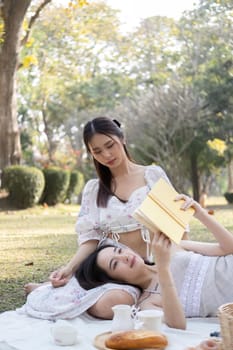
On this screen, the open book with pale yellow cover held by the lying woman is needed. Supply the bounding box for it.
[133,178,194,244]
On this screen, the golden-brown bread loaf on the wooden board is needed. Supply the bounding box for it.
[105,329,168,350]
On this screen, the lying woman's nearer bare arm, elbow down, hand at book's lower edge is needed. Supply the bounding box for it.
[142,232,186,329]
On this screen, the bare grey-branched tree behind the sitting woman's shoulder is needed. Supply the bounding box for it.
[116,79,197,191]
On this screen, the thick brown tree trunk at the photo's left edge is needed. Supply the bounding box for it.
[0,0,31,170]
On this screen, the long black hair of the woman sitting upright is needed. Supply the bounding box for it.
[83,117,132,208]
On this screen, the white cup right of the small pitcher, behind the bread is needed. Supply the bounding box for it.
[137,309,164,331]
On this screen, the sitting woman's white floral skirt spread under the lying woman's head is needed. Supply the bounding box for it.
[17,277,140,320]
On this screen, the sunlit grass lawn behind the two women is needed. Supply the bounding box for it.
[0,198,233,312]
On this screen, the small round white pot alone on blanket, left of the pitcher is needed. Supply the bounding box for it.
[51,320,78,345]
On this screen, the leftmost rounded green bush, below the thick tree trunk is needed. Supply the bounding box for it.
[2,165,45,209]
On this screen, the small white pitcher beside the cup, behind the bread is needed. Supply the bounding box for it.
[111,304,134,332]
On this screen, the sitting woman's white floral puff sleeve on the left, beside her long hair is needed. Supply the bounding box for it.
[75,179,101,245]
